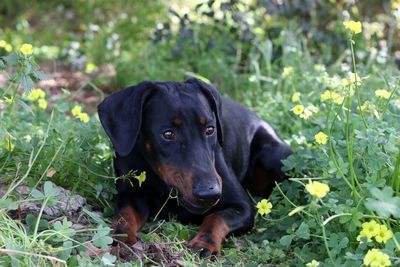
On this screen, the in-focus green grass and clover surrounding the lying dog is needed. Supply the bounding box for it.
[0,23,400,266]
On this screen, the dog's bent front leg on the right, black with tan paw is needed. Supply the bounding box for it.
[188,151,254,257]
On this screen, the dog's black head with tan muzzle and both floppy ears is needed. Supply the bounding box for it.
[98,78,223,214]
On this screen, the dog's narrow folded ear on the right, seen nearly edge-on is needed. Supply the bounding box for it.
[185,78,224,147]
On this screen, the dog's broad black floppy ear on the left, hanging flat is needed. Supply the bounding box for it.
[97,81,155,156]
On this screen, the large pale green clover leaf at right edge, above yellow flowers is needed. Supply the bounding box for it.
[365,186,400,218]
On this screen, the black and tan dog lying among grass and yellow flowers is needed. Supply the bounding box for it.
[98,78,291,256]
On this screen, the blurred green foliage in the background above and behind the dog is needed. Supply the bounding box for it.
[0,0,400,99]
